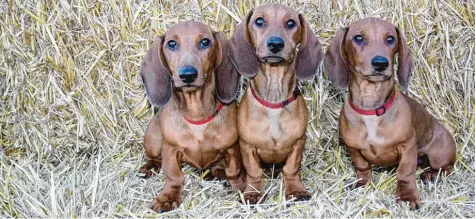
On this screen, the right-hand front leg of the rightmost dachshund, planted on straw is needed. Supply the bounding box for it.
[396,137,421,210]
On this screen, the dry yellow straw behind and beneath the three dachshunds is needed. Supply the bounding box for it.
[0,0,475,217]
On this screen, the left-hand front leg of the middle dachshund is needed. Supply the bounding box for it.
[240,139,263,204]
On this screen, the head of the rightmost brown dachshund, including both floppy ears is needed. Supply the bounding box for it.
[324,18,413,89]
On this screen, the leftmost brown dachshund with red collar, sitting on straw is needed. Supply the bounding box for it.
[140,22,246,211]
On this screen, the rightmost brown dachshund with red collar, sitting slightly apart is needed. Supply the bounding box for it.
[324,18,456,210]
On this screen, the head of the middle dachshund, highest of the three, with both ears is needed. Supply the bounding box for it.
[228,4,322,80]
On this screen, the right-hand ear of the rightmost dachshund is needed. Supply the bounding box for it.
[395,27,413,90]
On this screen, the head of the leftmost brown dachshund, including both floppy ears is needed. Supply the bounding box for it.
[141,21,239,106]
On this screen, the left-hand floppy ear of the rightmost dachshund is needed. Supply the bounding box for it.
[324,28,350,88]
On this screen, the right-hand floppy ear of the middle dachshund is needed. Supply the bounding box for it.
[295,14,322,80]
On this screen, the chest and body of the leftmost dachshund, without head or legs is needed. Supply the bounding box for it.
[152,92,239,169]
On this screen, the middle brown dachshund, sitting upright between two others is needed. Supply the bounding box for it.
[228,4,323,204]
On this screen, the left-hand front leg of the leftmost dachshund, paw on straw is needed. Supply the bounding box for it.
[152,144,184,212]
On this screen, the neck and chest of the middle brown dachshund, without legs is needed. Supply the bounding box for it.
[238,64,307,163]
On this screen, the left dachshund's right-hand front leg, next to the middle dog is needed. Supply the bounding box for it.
[225,142,246,192]
